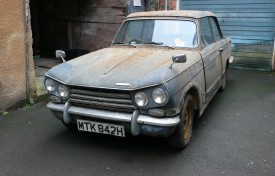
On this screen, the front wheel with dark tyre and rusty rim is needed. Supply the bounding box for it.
[168,94,194,149]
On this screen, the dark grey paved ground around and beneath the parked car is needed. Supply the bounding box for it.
[0,69,275,176]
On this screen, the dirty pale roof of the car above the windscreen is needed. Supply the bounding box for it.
[126,10,215,19]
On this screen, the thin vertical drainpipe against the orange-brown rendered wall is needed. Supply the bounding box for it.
[25,0,30,100]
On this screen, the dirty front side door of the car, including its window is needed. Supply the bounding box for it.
[200,17,222,102]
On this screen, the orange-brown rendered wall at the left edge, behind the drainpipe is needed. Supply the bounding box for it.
[0,0,35,112]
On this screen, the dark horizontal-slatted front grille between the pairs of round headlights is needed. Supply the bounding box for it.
[70,88,135,113]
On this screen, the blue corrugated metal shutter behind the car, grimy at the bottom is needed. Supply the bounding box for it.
[180,0,275,70]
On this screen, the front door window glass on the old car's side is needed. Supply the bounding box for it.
[200,17,215,46]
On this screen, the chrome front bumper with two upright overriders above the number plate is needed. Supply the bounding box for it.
[47,101,180,136]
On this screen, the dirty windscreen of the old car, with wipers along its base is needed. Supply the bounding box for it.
[113,20,198,48]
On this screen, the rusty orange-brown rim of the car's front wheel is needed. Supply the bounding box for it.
[183,105,192,140]
